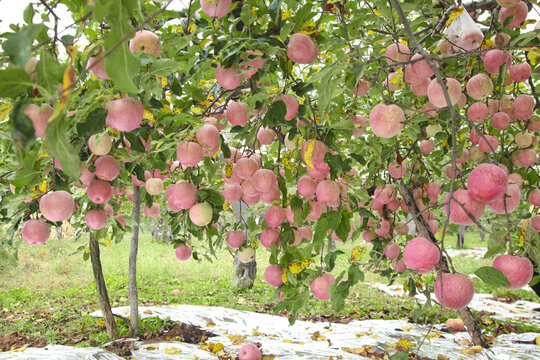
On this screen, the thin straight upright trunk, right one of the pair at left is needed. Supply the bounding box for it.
[128,185,141,336]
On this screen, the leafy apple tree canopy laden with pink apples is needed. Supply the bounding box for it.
[0,0,540,352]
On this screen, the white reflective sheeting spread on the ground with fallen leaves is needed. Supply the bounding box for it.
[0,305,540,360]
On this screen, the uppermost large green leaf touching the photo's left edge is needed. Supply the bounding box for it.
[2,24,47,68]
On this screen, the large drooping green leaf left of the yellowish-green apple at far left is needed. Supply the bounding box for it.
[45,114,81,179]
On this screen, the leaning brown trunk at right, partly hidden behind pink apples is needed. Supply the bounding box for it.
[400,181,489,348]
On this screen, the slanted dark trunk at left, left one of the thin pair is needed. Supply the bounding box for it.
[90,232,118,340]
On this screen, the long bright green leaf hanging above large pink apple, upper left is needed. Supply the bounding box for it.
[104,5,139,93]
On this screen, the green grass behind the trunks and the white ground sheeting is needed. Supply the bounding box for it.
[0,229,540,346]
